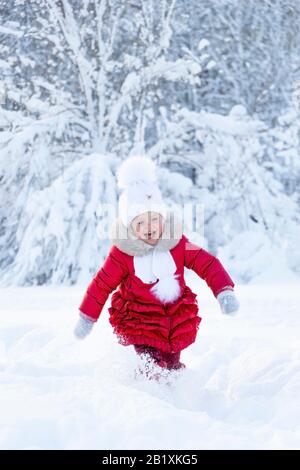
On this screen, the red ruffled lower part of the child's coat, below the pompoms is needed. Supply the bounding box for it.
[108,286,202,352]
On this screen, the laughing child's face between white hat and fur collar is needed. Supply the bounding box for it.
[131,212,164,245]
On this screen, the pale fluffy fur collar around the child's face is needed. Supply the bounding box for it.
[109,211,183,256]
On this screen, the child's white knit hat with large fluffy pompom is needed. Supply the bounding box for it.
[117,156,167,227]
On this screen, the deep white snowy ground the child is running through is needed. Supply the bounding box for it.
[0,277,300,450]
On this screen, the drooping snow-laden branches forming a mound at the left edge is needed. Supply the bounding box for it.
[0,153,116,286]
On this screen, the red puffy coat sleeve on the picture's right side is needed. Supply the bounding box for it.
[183,235,234,297]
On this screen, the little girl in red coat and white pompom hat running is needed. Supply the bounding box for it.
[74,157,239,378]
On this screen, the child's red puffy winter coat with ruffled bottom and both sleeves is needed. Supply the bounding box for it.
[79,235,234,352]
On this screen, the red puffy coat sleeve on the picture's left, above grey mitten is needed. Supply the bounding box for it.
[79,245,128,321]
